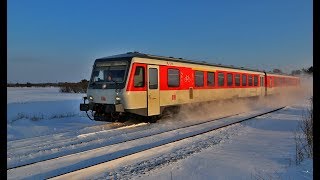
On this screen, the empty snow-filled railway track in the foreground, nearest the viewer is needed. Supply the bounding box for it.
[7,107,284,179]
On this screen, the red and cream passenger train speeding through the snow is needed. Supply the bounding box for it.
[80,52,300,122]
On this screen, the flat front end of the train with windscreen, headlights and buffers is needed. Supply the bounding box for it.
[80,58,130,121]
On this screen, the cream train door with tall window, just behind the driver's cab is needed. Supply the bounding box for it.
[147,65,160,116]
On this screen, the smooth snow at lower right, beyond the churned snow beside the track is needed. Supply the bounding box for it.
[134,104,313,179]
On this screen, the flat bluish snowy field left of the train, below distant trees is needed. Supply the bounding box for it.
[7,87,104,140]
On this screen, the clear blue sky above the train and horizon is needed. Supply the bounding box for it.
[7,0,313,82]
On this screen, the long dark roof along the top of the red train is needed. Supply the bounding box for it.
[96,52,298,76]
